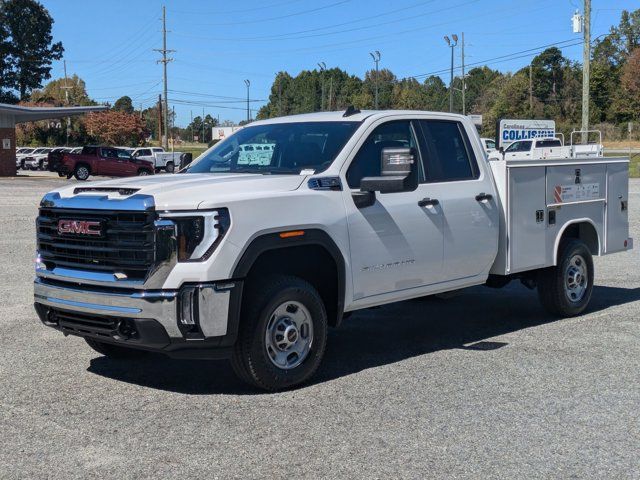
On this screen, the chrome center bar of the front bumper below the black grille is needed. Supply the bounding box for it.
[33,278,182,338]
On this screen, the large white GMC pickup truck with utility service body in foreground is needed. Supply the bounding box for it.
[34,108,633,390]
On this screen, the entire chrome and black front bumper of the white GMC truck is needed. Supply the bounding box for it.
[34,278,242,358]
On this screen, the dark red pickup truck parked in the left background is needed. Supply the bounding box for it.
[48,146,154,180]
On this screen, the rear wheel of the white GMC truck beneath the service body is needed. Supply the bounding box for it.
[538,238,594,317]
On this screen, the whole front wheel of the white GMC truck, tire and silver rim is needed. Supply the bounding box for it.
[231,276,327,391]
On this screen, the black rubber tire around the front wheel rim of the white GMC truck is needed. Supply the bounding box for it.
[231,276,328,391]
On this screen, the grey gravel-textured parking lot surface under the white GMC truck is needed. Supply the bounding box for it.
[0,174,640,479]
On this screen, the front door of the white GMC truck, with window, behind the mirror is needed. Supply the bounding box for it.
[345,120,444,300]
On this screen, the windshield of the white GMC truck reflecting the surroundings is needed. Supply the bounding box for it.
[186,122,360,175]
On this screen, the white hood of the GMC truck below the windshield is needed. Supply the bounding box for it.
[52,173,306,210]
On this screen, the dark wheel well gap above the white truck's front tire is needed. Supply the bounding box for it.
[245,248,342,326]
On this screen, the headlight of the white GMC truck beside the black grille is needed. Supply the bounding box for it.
[161,208,231,262]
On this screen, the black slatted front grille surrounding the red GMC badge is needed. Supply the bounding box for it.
[36,207,156,279]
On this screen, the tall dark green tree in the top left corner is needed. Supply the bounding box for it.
[0,0,64,100]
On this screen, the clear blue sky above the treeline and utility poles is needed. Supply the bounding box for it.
[42,0,640,126]
